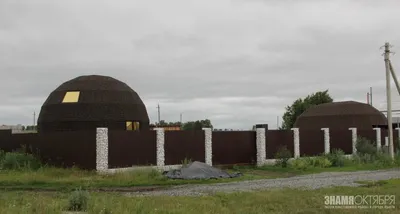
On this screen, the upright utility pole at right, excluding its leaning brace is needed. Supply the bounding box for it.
[384,42,394,159]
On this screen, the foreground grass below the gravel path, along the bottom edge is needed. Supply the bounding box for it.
[0,179,400,214]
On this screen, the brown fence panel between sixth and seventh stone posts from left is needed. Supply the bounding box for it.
[329,129,353,154]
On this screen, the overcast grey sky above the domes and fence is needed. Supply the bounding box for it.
[0,0,400,129]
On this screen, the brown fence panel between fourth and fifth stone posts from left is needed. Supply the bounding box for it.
[265,130,294,159]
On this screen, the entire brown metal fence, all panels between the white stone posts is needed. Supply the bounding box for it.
[0,126,399,169]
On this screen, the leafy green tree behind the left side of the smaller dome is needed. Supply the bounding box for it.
[279,90,333,130]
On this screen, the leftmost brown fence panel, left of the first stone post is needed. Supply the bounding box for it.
[0,130,96,169]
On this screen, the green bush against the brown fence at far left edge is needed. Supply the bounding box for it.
[0,152,41,170]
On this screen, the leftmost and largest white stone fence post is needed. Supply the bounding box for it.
[96,128,108,172]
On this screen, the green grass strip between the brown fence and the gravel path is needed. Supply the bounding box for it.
[0,164,396,191]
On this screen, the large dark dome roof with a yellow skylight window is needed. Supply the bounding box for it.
[38,75,149,131]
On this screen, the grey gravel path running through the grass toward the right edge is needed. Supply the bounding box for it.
[127,169,400,196]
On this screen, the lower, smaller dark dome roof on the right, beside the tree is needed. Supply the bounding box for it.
[294,101,387,129]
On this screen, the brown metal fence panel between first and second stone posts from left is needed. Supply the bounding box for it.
[108,130,156,169]
